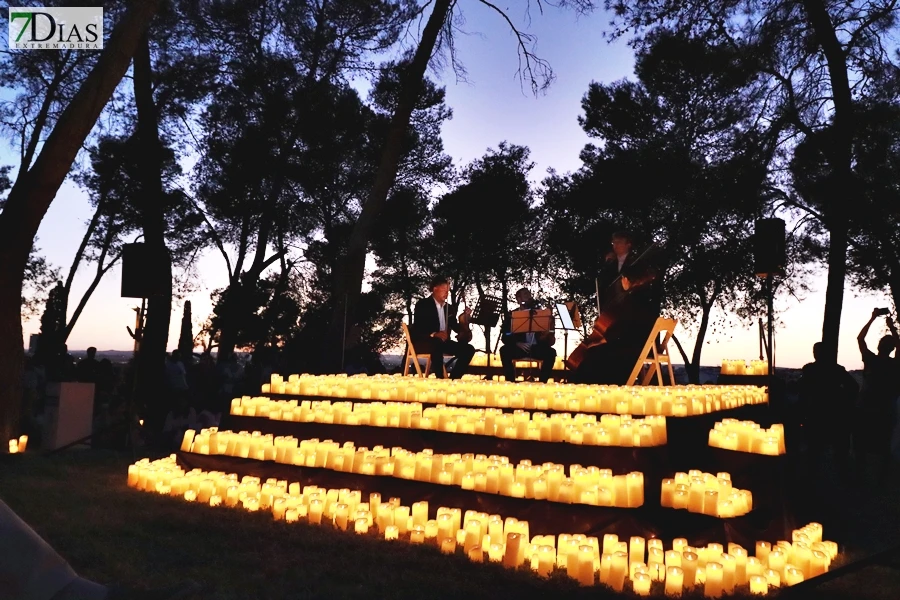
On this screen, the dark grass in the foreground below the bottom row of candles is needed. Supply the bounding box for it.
[0,450,900,600]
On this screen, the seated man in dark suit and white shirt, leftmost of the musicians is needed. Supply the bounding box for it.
[410,277,475,379]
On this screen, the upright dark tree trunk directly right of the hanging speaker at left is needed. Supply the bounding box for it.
[134,32,172,431]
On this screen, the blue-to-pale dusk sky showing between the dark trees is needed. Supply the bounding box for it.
[10,0,890,368]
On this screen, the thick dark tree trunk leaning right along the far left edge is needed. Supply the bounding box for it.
[0,0,160,440]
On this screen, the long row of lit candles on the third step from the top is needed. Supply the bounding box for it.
[181,428,644,508]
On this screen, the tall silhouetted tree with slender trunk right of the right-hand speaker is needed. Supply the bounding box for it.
[607,0,900,360]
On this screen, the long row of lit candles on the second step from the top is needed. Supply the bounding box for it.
[231,396,667,447]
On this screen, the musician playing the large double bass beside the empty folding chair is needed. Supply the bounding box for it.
[570,231,660,385]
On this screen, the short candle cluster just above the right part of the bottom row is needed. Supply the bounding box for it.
[660,470,753,519]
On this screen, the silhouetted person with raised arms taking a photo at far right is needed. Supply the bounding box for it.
[853,309,900,480]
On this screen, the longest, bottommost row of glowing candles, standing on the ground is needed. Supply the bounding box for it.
[128,455,838,598]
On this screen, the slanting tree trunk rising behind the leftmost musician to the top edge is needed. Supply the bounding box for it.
[323,0,453,372]
